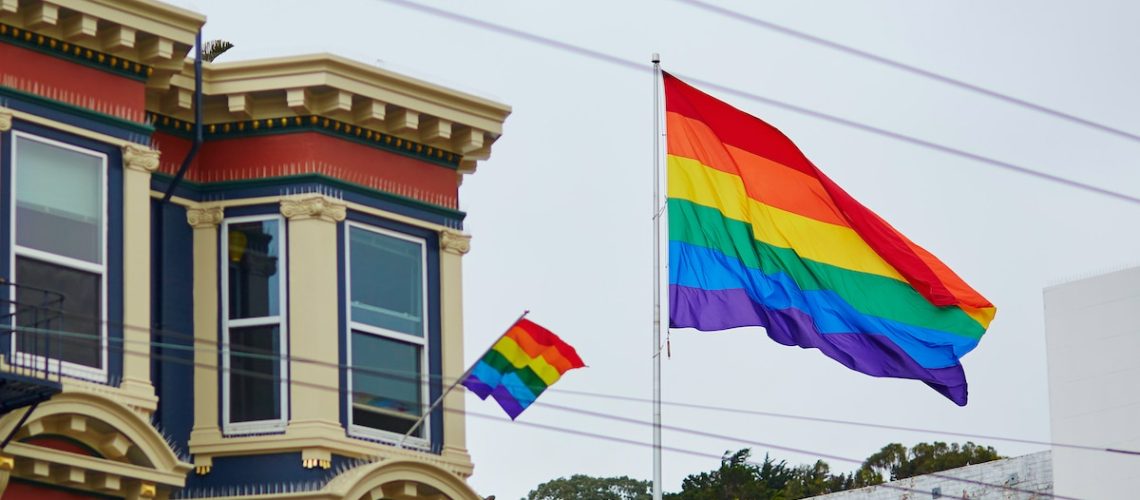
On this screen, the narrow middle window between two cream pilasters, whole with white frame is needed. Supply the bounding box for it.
[220,215,287,434]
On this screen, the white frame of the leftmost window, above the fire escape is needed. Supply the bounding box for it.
[8,130,108,384]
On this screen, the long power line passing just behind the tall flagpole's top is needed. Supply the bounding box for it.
[378,0,1140,205]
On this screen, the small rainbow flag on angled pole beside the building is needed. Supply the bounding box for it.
[463,319,586,420]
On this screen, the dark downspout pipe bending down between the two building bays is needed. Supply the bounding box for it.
[150,33,202,416]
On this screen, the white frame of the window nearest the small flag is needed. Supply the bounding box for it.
[344,222,432,450]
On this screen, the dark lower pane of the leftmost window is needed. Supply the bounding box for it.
[16,257,103,368]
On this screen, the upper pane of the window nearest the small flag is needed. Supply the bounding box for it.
[349,228,424,337]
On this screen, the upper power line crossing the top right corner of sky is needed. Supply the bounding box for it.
[674,0,1140,142]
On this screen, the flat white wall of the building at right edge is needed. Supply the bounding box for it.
[1044,268,1140,499]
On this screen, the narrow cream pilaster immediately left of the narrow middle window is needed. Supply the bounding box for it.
[186,207,225,448]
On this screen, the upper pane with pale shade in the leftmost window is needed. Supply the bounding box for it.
[16,137,103,263]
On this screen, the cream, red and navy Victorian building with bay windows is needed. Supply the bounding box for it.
[0,0,510,499]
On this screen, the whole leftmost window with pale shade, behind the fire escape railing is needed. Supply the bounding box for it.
[11,132,107,380]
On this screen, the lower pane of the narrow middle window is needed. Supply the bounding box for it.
[229,325,282,423]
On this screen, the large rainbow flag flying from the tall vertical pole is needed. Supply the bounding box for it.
[665,74,996,405]
